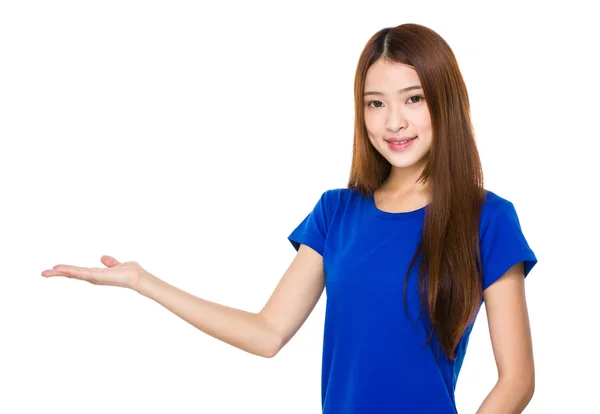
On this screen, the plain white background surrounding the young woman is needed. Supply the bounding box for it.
[0,0,600,414]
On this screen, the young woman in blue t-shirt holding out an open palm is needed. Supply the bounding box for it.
[42,24,537,414]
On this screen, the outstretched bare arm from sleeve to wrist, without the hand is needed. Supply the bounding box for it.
[135,245,325,358]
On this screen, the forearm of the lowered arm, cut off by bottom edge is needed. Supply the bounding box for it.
[477,379,534,414]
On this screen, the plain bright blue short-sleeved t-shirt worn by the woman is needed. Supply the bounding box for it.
[289,188,537,414]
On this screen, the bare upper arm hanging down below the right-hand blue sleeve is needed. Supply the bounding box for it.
[483,262,534,386]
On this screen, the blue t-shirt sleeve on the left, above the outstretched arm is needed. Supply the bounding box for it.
[288,190,331,256]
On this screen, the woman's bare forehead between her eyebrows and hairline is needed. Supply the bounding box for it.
[365,59,420,90]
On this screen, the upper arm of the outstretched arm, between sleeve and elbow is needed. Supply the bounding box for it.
[260,244,325,352]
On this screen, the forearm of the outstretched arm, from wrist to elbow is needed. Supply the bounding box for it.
[135,272,279,358]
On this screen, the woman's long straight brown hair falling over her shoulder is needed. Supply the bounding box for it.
[348,23,485,359]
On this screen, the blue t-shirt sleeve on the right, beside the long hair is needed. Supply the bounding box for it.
[480,200,537,290]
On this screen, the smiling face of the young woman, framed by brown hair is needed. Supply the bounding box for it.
[364,59,432,169]
